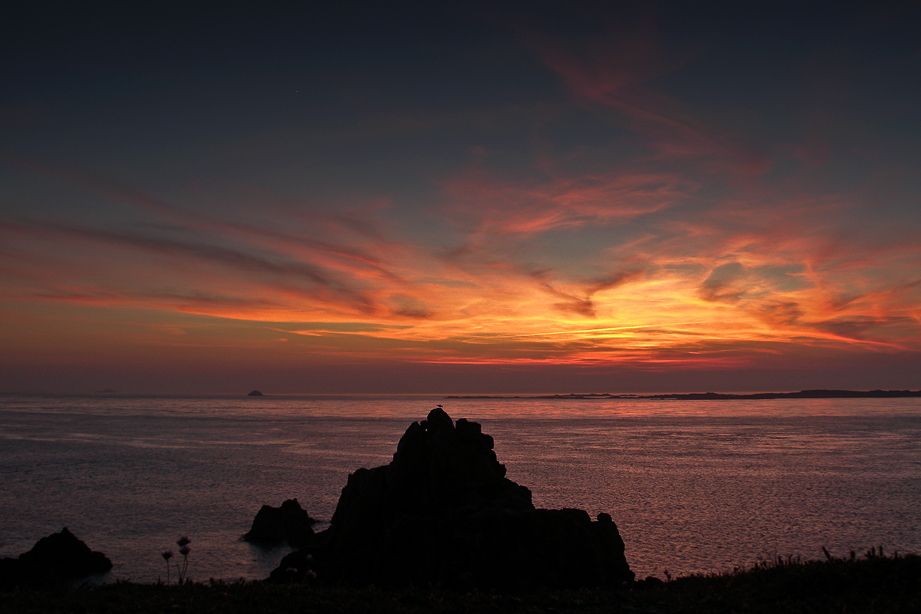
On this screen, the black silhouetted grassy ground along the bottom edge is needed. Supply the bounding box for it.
[0,551,921,614]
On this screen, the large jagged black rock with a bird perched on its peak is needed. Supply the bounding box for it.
[276,407,634,589]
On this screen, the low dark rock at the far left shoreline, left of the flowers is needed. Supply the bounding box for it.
[0,527,112,586]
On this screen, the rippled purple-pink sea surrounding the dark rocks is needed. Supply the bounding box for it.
[0,396,921,582]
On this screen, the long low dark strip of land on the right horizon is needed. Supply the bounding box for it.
[445,390,921,401]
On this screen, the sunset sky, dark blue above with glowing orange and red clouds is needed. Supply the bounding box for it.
[0,2,921,394]
